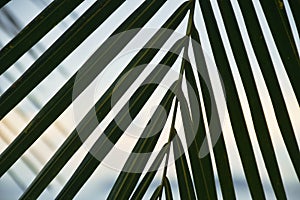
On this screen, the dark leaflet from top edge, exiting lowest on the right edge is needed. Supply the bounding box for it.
[237,1,300,177]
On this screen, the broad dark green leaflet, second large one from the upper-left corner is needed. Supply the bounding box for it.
[0,0,124,119]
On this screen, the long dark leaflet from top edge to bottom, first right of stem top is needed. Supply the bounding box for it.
[199,1,265,199]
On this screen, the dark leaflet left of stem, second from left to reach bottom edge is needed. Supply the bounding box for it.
[58,36,184,198]
